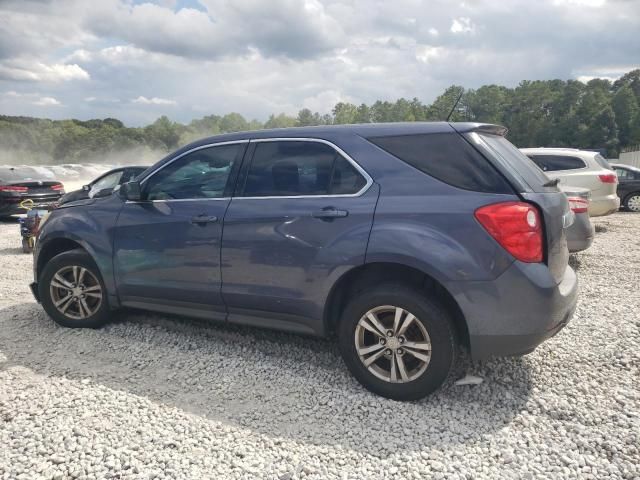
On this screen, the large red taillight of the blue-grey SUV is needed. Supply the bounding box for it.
[475,202,543,263]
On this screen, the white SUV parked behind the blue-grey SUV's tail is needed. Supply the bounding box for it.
[520,148,620,217]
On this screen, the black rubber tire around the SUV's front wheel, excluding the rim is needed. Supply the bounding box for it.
[38,249,110,328]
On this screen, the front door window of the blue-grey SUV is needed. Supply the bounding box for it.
[145,144,245,200]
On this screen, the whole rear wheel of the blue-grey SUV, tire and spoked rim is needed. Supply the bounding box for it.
[338,283,457,401]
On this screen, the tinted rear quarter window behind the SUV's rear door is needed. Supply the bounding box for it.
[367,133,512,193]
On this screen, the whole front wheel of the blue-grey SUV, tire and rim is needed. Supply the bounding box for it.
[38,249,110,328]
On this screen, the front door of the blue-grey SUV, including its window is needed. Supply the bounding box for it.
[113,141,247,319]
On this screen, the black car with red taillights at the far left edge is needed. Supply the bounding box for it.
[0,167,64,218]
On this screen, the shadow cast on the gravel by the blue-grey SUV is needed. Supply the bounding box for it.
[0,303,531,458]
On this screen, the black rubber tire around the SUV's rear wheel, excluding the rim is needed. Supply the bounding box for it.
[338,283,457,401]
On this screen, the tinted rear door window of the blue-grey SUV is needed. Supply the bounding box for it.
[243,141,366,197]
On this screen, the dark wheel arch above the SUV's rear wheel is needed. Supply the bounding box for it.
[323,262,469,348]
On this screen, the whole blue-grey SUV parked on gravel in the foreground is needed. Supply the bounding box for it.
[31,122,578,400]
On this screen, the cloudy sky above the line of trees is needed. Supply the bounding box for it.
[0,0,640,126]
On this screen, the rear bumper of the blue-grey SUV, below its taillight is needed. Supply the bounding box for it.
[449,262,578,360]
